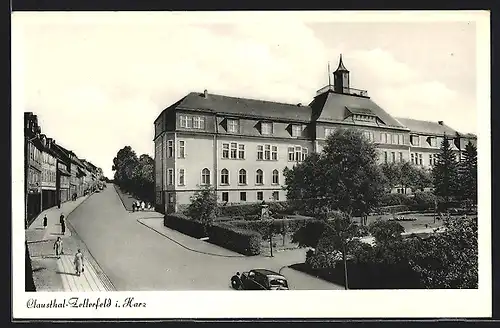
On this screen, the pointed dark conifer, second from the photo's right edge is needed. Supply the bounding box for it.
[432,136,458,207]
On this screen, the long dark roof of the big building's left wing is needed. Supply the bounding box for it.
[176,92,311,121]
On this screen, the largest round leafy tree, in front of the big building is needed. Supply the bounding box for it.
[285,129,384,220]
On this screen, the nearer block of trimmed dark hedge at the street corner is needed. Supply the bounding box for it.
[208,223,262,255]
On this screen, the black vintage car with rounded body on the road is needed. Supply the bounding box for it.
[231,269,289,290]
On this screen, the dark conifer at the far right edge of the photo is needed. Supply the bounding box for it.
[459,141,477,210]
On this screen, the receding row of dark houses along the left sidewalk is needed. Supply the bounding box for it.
[24,112,103,226]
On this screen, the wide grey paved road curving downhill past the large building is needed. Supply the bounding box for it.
[68,184,342,291]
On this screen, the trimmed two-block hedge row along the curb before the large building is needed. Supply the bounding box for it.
[163,213,262,255]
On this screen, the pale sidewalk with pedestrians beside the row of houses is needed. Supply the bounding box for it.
[26,195,114,292]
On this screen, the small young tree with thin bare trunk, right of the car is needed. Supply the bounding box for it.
[316,213,359,289]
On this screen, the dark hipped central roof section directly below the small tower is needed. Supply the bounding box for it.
[309,91,404,128]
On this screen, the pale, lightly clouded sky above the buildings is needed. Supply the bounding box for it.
[12,13,484,178]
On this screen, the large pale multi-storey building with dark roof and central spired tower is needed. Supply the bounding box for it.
[154,56,475,213]
